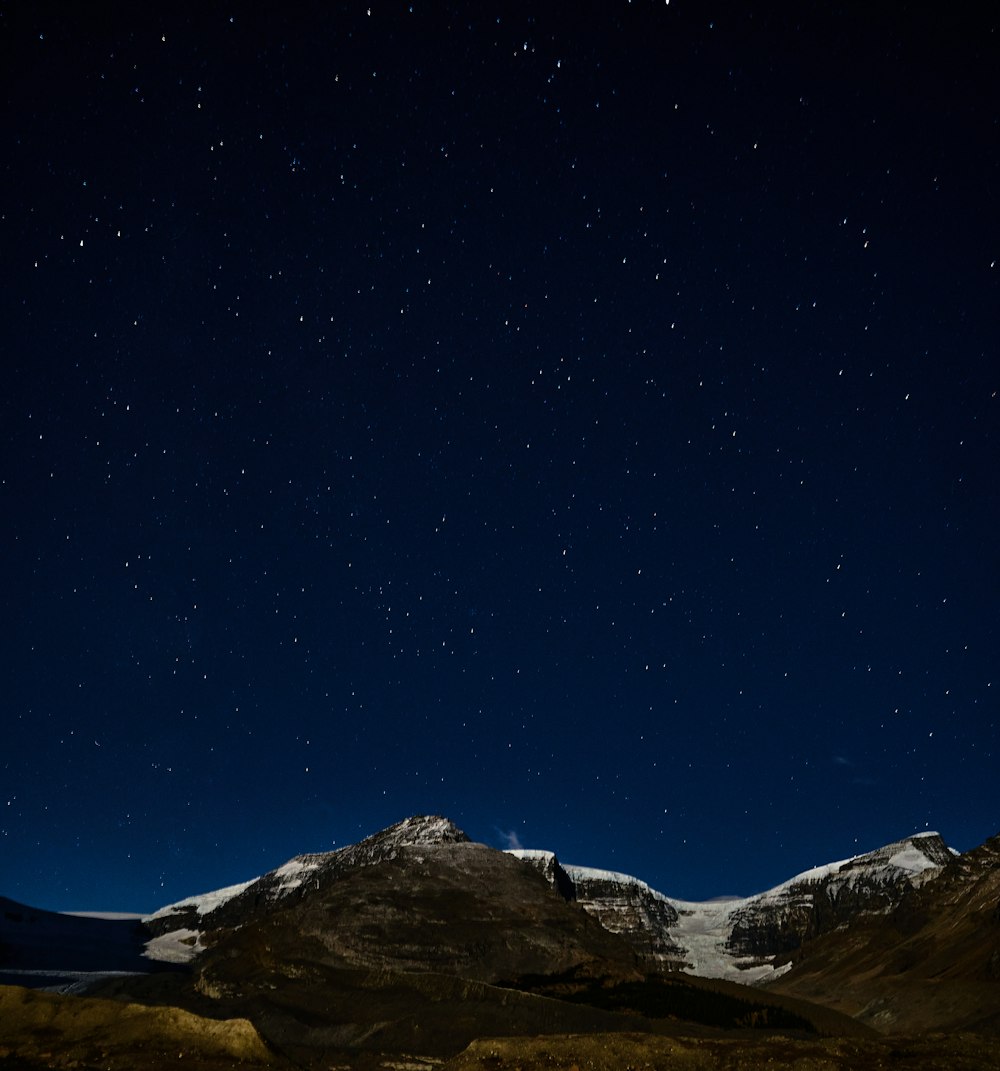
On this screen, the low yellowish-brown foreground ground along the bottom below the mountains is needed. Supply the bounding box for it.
[0,986,1000,1071]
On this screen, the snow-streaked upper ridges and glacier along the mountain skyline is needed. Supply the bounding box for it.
[143,816,954,983]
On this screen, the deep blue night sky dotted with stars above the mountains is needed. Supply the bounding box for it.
[0,0,1000,911]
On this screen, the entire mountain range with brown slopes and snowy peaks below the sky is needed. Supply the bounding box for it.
[0,815,1000,1071]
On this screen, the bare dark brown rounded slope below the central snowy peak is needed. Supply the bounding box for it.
[190,840,635,982]
